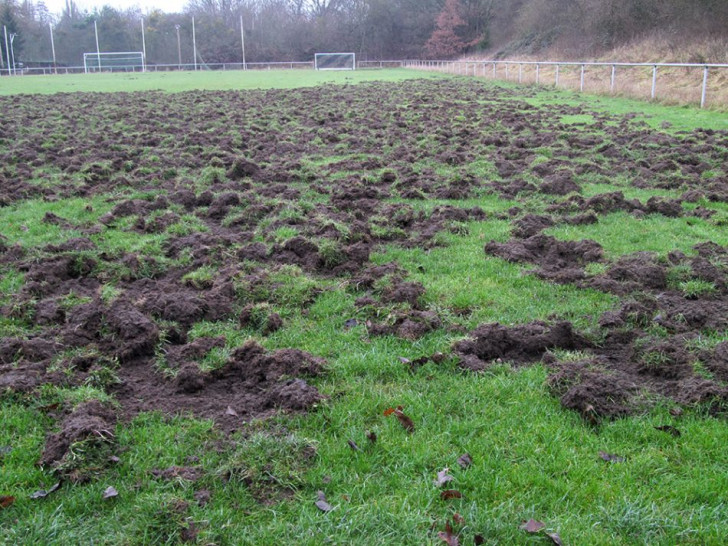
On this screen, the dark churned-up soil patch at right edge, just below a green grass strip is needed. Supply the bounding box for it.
[460,236,728,418]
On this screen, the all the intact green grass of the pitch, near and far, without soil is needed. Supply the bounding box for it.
[0,70,728,546]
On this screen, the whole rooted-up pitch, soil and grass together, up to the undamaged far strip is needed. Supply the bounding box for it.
[0,71,728,545]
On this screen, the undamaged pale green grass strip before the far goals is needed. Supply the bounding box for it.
[0,69,448,95]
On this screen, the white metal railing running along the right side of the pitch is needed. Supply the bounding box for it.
[403,60,728,108]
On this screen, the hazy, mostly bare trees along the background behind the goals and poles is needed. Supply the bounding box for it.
[0,0,728,66]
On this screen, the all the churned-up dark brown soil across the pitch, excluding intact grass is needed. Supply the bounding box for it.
[0,80,728,464]
